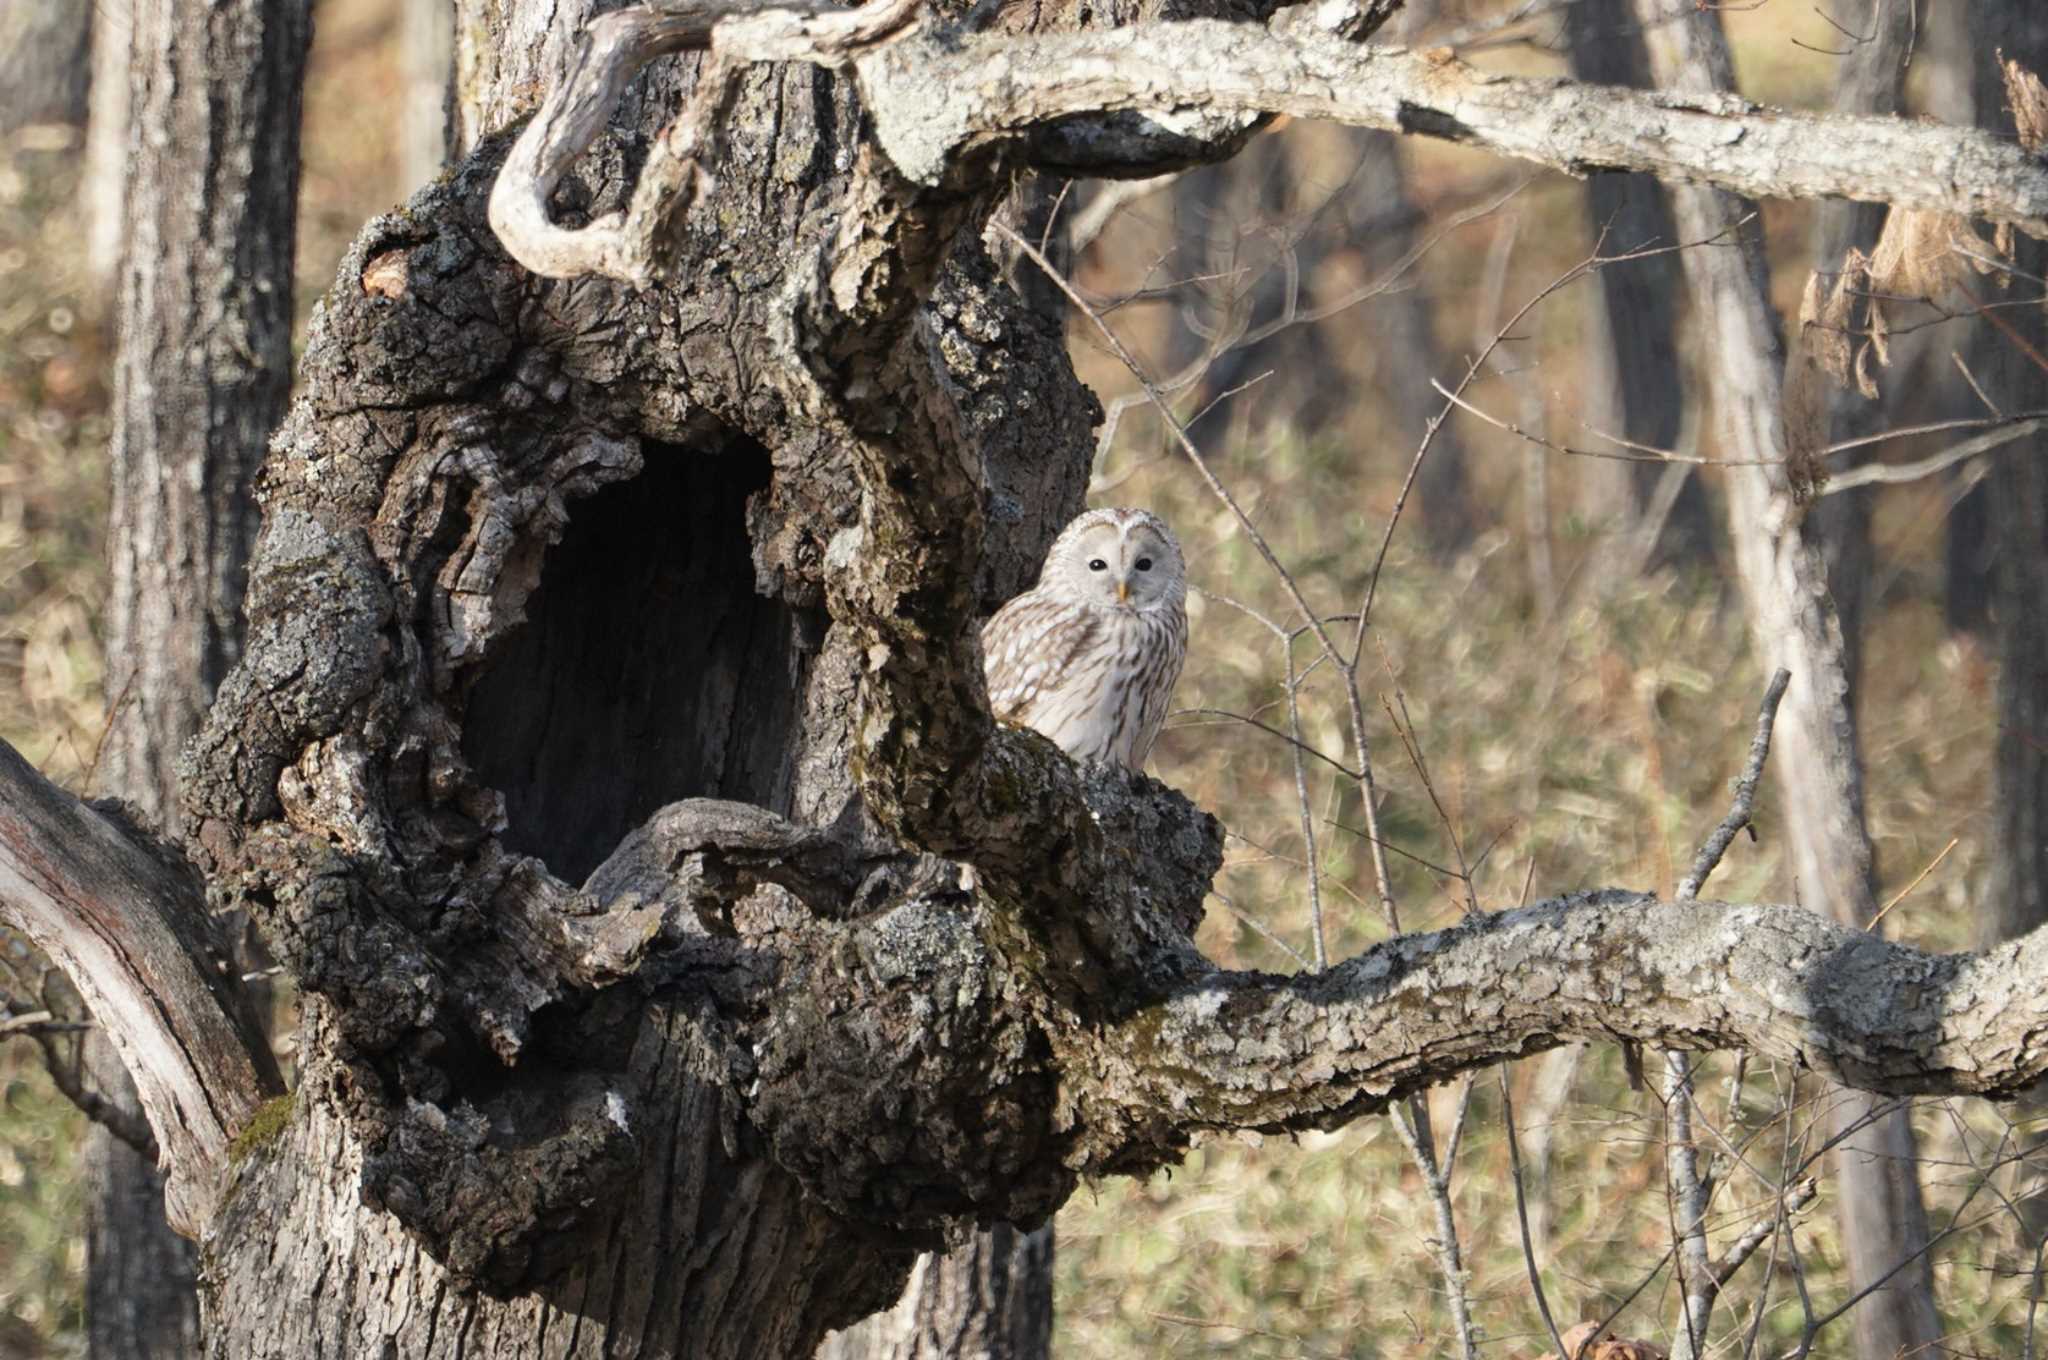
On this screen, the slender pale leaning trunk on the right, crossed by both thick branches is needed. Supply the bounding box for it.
[1634,0,1942,1356]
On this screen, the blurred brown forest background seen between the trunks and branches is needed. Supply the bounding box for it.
[0,0,2048,1358]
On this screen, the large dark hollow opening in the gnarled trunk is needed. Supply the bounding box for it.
[463,444,799,883]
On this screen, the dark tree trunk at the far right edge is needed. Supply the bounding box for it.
[1970,2,2048,942]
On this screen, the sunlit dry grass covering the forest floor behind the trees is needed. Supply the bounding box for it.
[0,0,2028,1356]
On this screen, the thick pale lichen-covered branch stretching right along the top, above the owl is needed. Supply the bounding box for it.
[854,20,2048,236]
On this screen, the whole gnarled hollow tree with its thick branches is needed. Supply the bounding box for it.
[12,2,2048,1356]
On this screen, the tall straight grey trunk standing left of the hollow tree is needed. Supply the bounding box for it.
[86,0,311,1358]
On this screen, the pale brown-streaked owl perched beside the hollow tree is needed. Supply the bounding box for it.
[981,508,1188,770]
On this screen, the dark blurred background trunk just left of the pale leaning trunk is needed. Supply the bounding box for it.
[1544,0,1714,582]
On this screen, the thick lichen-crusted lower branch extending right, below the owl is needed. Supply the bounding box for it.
[1102,891,2048,1131]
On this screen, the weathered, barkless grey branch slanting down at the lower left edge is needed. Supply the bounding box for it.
[0,741,285,1235]
